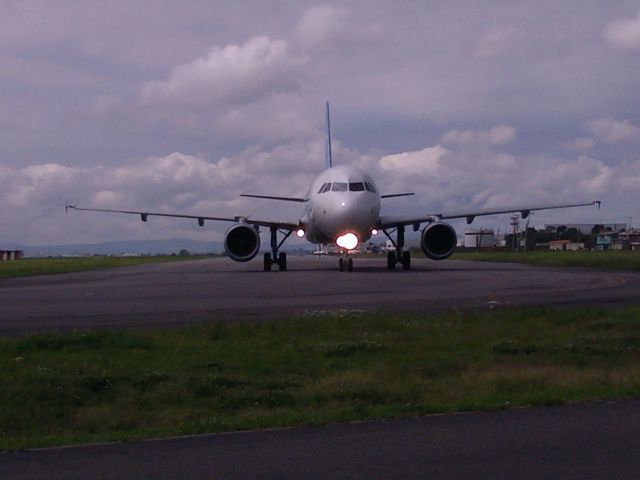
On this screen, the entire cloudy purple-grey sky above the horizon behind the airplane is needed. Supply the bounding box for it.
[0,0,640,247]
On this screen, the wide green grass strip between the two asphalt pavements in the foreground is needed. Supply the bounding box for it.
[0,308,640,449]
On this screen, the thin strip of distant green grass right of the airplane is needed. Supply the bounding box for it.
[451,250,640,271]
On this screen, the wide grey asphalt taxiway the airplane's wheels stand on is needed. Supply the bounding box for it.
[0,257,640,335]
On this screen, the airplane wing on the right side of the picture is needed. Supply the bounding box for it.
[378,200,601,228]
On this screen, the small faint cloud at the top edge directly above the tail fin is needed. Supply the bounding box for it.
[293,5,347,48]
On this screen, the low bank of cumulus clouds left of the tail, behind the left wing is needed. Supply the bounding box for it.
[0,144,322,245]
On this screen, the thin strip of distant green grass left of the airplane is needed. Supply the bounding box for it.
[0,255,210,278]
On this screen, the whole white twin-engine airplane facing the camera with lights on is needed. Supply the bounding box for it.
[66,102,601,272]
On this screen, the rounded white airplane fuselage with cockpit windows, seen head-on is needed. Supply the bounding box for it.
[300,165,380,248]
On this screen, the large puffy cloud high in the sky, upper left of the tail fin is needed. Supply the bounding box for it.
[140,36,303,108]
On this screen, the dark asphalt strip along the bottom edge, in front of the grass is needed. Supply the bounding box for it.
[5,400,640,480]
